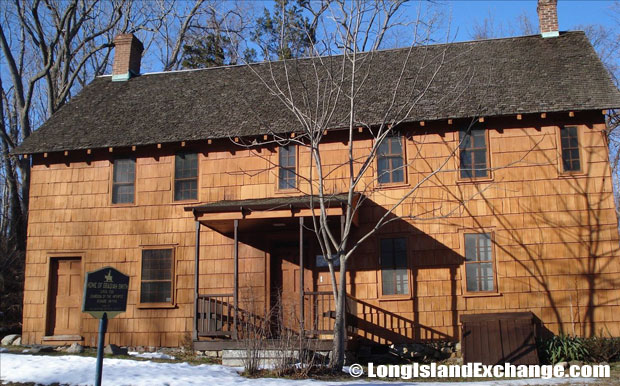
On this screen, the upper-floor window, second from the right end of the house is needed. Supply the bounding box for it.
[459,129,488,178]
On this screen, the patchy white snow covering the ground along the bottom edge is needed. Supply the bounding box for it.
[0,353,587,386]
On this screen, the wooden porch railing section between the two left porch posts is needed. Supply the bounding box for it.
[196,294,236,337]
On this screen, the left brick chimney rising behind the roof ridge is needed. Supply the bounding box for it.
[112,34,144,82]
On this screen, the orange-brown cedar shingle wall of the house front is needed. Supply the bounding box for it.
[23,116,620,346]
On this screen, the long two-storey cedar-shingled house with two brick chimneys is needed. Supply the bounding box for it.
[15,1,620,349]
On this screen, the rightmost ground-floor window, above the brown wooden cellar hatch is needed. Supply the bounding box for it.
[465,233,495,292]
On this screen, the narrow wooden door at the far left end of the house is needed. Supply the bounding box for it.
[48,257,84,335]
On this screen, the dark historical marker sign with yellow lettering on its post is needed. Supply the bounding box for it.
[82,267,129,386]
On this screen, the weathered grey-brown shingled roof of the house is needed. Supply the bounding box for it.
[14,32,620,154]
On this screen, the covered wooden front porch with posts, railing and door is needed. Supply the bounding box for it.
[186,195,359,350]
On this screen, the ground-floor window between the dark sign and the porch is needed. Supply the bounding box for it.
[140,249,173,303]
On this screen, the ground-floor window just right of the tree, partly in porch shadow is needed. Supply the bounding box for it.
[381,238,409,295]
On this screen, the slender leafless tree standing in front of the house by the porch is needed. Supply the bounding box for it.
[225,0,482,369]
